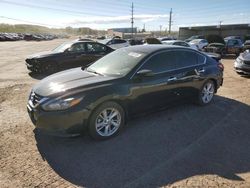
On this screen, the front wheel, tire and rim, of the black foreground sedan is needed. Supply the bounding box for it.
[89,102,125,140]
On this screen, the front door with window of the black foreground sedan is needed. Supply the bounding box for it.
[130,51,180,113]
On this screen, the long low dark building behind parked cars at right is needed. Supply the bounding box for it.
[179,24,250,40]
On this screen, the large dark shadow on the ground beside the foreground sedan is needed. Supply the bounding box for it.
[35,96,250,188]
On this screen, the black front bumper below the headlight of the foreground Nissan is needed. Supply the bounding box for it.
[27,103,90,135]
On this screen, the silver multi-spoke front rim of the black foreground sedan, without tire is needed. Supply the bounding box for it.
[95,108,121,136]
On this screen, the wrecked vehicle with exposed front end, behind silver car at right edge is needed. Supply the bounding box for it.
[224,39,243,56]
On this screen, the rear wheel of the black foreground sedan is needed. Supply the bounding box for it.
[197,80,216,106]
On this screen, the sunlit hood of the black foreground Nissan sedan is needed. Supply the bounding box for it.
[32,68,117,97]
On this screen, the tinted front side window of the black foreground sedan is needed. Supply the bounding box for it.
[141,51,176,73]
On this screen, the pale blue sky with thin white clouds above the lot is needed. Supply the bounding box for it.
[0,0,250,31]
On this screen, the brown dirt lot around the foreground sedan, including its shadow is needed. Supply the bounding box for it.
[0,40,250,188]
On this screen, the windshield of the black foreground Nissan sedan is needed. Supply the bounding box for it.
[85,48,146,77]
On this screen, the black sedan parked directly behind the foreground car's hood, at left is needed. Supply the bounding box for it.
[26,41,114,73]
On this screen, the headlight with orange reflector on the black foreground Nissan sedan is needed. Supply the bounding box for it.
[42,97,83,111]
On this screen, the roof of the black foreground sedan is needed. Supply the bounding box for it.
[123,44,190,54]
